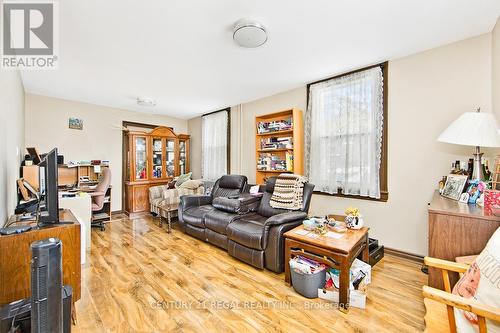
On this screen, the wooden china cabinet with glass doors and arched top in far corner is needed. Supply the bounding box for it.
[123,126,189,215]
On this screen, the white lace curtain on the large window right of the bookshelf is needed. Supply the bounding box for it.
[305,67,384,198]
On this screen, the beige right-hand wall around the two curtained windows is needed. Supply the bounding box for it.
[190,34,491,255]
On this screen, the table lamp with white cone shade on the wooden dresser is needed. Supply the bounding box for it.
[438,108,500,180]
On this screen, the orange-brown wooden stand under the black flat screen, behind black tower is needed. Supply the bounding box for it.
[0,209,81,304]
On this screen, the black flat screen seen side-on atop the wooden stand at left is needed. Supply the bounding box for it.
[38,148,59,225]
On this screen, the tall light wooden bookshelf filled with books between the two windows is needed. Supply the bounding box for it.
[255,108,304,184]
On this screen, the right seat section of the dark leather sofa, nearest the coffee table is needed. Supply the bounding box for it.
[226,178,314,273]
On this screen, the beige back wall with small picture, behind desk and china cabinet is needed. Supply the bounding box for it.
[26,94,188,211]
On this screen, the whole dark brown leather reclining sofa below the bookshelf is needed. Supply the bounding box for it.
[179,175,314,273]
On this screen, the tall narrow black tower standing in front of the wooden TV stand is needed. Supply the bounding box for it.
[31,238,63,333]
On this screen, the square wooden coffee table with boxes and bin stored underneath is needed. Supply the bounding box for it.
[284,226,369,312]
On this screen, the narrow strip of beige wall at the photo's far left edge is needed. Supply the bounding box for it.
[0,70,24,226]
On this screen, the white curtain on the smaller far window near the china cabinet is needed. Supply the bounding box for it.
[201,111,228,180]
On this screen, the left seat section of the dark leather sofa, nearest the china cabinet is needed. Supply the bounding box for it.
[178,175,247,241]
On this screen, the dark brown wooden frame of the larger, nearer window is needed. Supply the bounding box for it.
[306,61,389,202]
